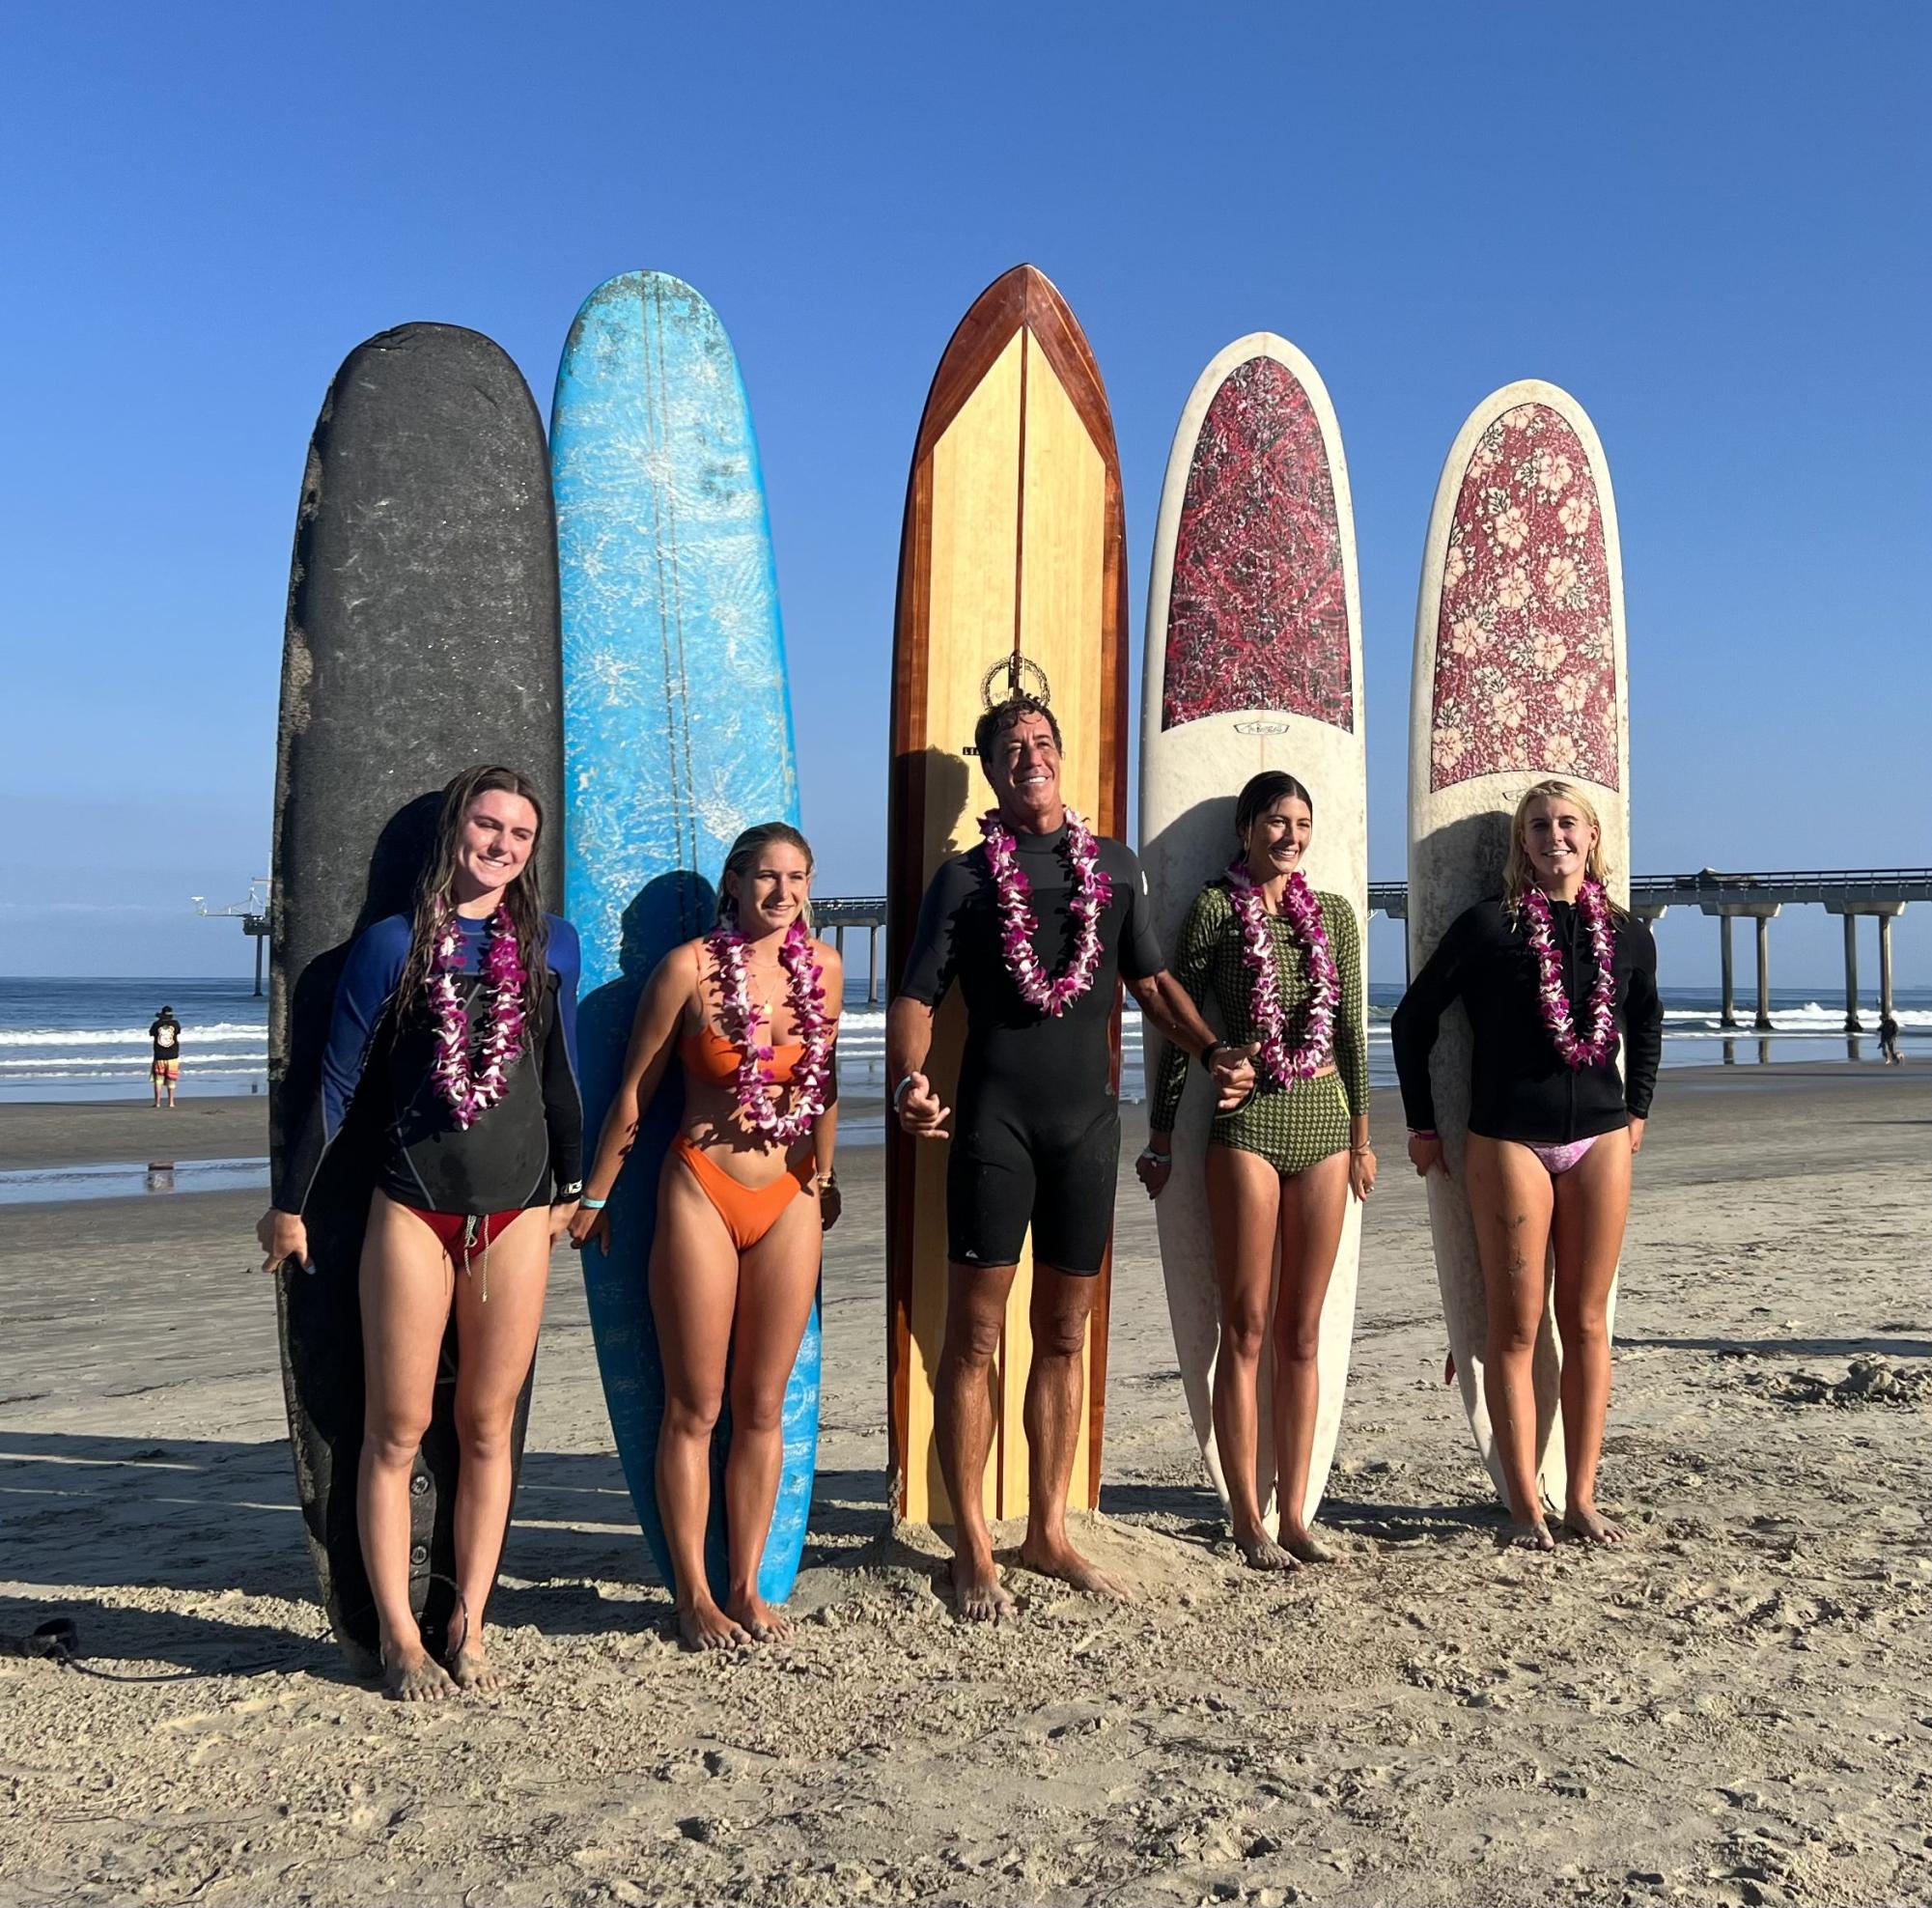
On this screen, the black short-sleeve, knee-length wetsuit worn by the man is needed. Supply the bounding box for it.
[898,828,1163,1273]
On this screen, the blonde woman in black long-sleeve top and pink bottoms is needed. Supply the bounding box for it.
[1391,780,1664,1551]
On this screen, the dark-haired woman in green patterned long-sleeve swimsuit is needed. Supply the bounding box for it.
[1136,771,1376,1570]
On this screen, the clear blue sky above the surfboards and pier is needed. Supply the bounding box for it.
[0,4,1932,983]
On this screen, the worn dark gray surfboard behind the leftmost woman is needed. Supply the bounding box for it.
[268,324,564,1670]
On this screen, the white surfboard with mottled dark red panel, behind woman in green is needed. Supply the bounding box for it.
[1140,332,1368,1531]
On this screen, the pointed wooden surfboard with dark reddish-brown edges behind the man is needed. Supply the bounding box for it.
[886,265,1127,1524]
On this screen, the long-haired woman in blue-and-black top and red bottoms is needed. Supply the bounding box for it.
[257,769,583,1701]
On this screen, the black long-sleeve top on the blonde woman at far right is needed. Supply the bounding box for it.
[1389,900,1664,1145]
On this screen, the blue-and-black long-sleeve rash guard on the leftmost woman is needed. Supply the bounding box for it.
[276,913,583,1215]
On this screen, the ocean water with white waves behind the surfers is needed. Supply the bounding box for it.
[0,977,1932,1101]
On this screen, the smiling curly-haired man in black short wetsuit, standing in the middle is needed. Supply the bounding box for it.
[886,697,1254,1622]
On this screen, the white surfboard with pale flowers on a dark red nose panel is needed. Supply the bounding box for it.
[1409,379,1631,1504]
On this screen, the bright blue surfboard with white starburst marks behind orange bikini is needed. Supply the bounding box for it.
[550,272,819,1603]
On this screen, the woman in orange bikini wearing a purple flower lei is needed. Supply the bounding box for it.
[570,821,844,1649]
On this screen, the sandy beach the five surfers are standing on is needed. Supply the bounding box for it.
[0,1064,1932,1904]
